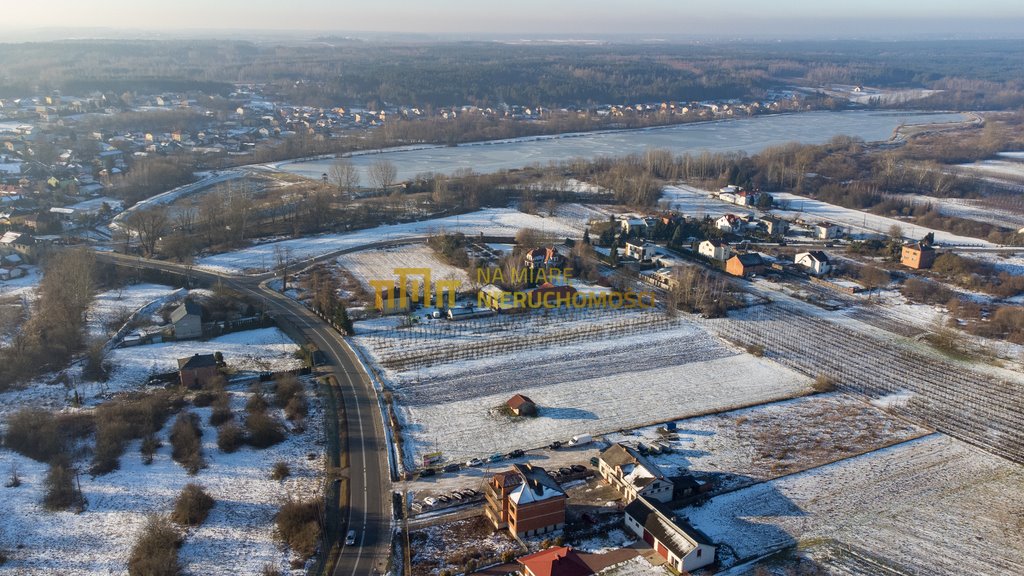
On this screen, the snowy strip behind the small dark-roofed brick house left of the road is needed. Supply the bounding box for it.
[0,328,302,417]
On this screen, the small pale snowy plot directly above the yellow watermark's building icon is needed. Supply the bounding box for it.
[338,244,469,290]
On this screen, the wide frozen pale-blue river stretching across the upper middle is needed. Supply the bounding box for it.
[279,111,964,186]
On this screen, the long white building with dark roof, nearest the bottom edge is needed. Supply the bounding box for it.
[625,498,716,574]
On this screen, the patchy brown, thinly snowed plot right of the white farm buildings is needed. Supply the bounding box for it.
[605,394,929,490]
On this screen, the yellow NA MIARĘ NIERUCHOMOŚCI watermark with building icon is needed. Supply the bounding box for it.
[370,268,656,312]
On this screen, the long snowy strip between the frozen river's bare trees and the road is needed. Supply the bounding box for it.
[198,208,578,274]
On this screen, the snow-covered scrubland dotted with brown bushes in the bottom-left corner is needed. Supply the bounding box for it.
[0,377,323,576]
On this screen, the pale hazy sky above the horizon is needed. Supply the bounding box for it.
[6,0,1024,37]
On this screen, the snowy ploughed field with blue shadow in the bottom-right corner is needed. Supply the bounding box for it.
[680,435,1024,575]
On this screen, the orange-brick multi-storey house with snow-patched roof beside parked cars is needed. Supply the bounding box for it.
[483,463,568,537]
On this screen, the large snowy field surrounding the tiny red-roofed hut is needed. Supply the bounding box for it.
[355,317,810,462]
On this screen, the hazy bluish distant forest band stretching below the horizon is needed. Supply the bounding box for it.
[0,38,1024,110]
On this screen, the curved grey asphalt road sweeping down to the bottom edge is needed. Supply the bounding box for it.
[96,252,391,576]
